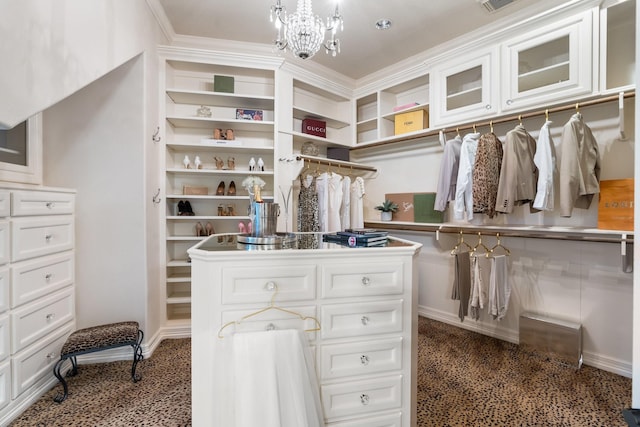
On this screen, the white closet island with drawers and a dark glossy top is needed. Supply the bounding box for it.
[188,234,422,427]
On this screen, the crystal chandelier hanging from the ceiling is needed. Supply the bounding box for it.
[271,0,343,59]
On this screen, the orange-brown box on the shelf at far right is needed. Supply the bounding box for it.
[598,178,634,231]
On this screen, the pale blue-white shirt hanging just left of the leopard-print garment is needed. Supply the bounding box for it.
[453,133,480,220]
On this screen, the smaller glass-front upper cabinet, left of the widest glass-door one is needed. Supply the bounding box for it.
[431,48,499,125]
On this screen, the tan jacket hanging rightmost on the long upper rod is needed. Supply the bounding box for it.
[559,113,600,217]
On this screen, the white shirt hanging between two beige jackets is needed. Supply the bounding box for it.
[533,121,557,211]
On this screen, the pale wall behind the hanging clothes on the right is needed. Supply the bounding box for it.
[355,99,635,376]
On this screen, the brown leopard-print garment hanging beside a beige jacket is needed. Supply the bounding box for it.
[472,133,502,218]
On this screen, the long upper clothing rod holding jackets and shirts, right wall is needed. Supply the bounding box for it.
[349,91,636,151]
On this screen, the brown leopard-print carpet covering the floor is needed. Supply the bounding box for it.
[11,317,631,427]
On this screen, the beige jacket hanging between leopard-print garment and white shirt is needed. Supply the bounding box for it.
[496,125,538,213]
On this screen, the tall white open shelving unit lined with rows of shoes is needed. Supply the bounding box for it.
[160,47,275,325]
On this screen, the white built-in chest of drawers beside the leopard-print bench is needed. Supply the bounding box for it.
[0,188,75,425]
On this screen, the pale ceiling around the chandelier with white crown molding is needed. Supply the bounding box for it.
[155,0,576,79]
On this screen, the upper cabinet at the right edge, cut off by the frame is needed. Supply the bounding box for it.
[600,0,636,92]
